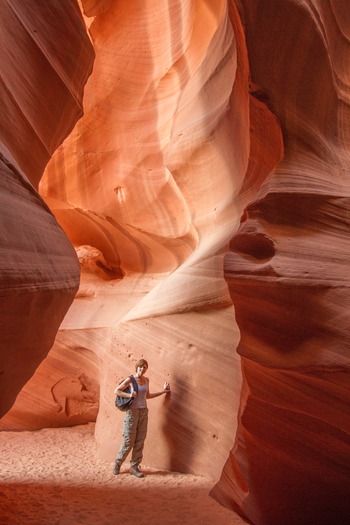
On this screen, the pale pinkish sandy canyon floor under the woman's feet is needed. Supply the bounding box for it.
[0,424,245,525]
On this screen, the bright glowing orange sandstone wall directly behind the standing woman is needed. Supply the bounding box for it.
[2,0,282,479]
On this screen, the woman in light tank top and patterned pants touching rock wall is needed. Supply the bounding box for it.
[113,359,170,478]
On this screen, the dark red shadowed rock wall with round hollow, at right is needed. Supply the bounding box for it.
[213,0,350,525]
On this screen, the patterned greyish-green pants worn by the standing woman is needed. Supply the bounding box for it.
[115,408,148,467]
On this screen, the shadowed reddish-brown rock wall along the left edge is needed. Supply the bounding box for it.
[0,0,93,418]
